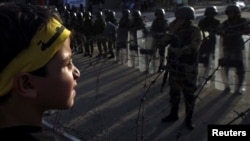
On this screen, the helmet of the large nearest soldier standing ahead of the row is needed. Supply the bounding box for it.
[175,6,195,20]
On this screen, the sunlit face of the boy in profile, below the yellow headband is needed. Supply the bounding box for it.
[32,38,80,109]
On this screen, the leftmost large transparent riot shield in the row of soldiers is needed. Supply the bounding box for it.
[115,28,129,64]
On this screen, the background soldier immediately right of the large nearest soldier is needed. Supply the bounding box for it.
[198,6,220,86]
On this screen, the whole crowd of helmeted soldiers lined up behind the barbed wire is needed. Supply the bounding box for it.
[48,5,250,129]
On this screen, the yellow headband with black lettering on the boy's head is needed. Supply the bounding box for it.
[0,18,70,96]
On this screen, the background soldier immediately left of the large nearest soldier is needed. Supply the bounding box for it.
[150,8,168,72]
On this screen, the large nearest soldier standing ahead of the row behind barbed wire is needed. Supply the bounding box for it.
[162,6,202,130]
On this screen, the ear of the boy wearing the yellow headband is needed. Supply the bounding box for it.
[13,73,37,98]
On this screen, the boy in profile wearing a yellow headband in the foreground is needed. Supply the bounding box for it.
[0,3,80,141]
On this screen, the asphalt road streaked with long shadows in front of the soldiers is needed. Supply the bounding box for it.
[44,3,250,141]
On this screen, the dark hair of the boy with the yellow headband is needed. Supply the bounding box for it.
[0,3,62,104]
